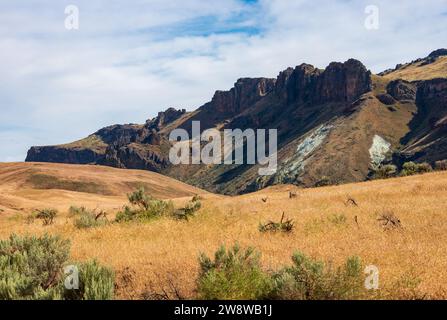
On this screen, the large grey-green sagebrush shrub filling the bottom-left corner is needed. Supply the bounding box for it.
[0,235,70,300]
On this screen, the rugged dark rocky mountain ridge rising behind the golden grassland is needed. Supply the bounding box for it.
[26,50,447,194]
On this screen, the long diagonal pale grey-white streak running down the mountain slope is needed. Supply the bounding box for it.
[275,125,333,183]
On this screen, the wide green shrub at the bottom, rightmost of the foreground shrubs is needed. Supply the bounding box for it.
[271,253,365,300]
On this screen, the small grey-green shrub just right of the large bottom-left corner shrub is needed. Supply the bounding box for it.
[64,260,115,300]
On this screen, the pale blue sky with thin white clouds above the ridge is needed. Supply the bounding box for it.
[0,0,447,161]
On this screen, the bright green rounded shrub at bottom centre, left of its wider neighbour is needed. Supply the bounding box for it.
[197,244,273,300]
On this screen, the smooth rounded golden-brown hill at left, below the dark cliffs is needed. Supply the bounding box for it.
[0,163,207,213]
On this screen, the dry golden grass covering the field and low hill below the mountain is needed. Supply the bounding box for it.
[0,164,447,299]
